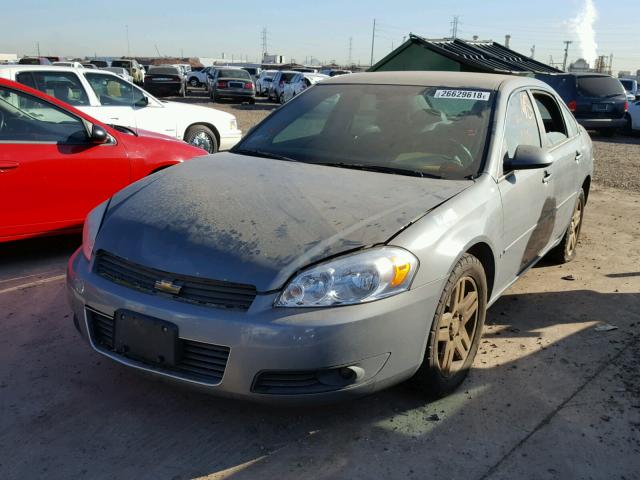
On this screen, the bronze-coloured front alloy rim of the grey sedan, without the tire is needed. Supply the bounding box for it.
[437,276,479,376]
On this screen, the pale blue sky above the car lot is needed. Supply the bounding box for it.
[0,0,640,72]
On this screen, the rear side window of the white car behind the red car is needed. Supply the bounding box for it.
[16,70,89,106]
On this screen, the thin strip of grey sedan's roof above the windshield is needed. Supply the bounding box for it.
[322,71,549,90]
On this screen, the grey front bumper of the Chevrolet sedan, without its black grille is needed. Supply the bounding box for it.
[67,250,442,404]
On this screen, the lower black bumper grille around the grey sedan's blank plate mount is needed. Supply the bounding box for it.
[87,309,230,384]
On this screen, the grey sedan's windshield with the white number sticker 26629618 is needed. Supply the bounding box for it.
[233,84,494,179]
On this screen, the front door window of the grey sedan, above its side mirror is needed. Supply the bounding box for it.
[504,91,542,158]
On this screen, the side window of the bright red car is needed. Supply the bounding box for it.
[0,87,87,144]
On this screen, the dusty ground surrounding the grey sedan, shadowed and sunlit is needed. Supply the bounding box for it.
[0,91,640,480]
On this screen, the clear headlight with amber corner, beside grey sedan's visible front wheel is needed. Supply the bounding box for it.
[275,247,418,307]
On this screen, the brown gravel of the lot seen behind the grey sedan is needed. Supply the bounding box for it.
[180,90,640,192]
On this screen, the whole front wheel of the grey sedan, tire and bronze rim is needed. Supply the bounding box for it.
[412,253,487,398]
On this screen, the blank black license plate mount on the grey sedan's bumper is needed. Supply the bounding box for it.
[114,310,182,367]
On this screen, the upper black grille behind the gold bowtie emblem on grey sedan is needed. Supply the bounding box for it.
[95,250,256,310]
